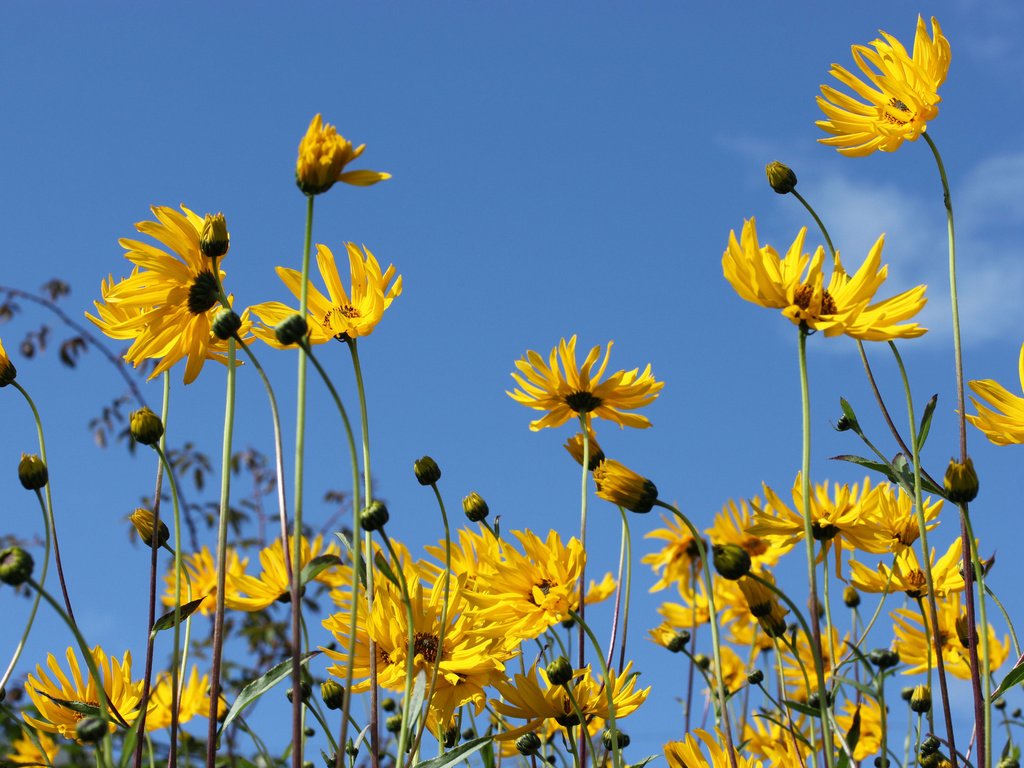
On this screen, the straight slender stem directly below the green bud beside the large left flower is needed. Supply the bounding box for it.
[206,339,236,768]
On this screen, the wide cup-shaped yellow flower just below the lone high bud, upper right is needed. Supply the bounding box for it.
[722,218,927,341]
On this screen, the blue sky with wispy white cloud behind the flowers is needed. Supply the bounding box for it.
[0,2,1024,757]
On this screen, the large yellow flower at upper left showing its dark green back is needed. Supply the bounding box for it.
[86,206,251,384]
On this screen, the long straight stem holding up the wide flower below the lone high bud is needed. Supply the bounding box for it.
[798,325,836,768]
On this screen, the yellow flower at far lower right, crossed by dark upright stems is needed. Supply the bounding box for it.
[890,593,1010,680]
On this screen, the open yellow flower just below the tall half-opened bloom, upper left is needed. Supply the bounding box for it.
[252,243,401,349]
